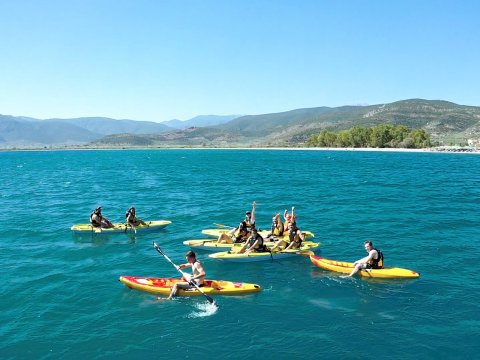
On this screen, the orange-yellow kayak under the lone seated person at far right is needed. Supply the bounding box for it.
[310,255,420,279]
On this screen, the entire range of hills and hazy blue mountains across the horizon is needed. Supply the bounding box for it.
[0,99,480,148]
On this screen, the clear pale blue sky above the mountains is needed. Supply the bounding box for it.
[0,0,480,121]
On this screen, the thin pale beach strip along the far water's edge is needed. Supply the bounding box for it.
[0,146,480,154]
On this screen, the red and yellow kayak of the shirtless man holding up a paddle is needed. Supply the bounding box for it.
[119,276,262,296]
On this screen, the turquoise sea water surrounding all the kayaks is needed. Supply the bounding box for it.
[0,150,480,359]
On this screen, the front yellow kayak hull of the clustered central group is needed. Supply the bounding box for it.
[208,243,319,262]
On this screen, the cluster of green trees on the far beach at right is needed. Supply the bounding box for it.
[306,124,431,149]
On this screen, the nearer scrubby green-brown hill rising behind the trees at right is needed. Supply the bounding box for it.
[93,99,480,146]
